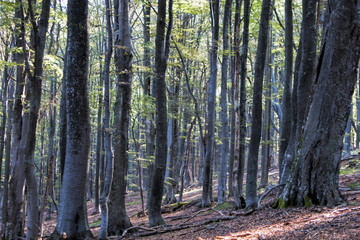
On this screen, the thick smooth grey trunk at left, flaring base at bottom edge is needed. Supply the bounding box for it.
[50,0,92,239]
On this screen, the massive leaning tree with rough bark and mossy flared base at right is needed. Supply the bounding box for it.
[277,0,360,207]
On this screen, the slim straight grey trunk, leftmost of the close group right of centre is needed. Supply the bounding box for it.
[201,0,220,208]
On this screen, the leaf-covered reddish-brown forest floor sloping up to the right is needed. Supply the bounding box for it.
[44,156,360,240]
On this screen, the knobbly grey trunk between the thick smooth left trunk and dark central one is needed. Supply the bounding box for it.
[107,0,132,235]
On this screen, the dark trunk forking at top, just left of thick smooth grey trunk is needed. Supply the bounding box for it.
[22,0,51,239]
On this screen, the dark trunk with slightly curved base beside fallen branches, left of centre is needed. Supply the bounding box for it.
[148,0,173,226]
